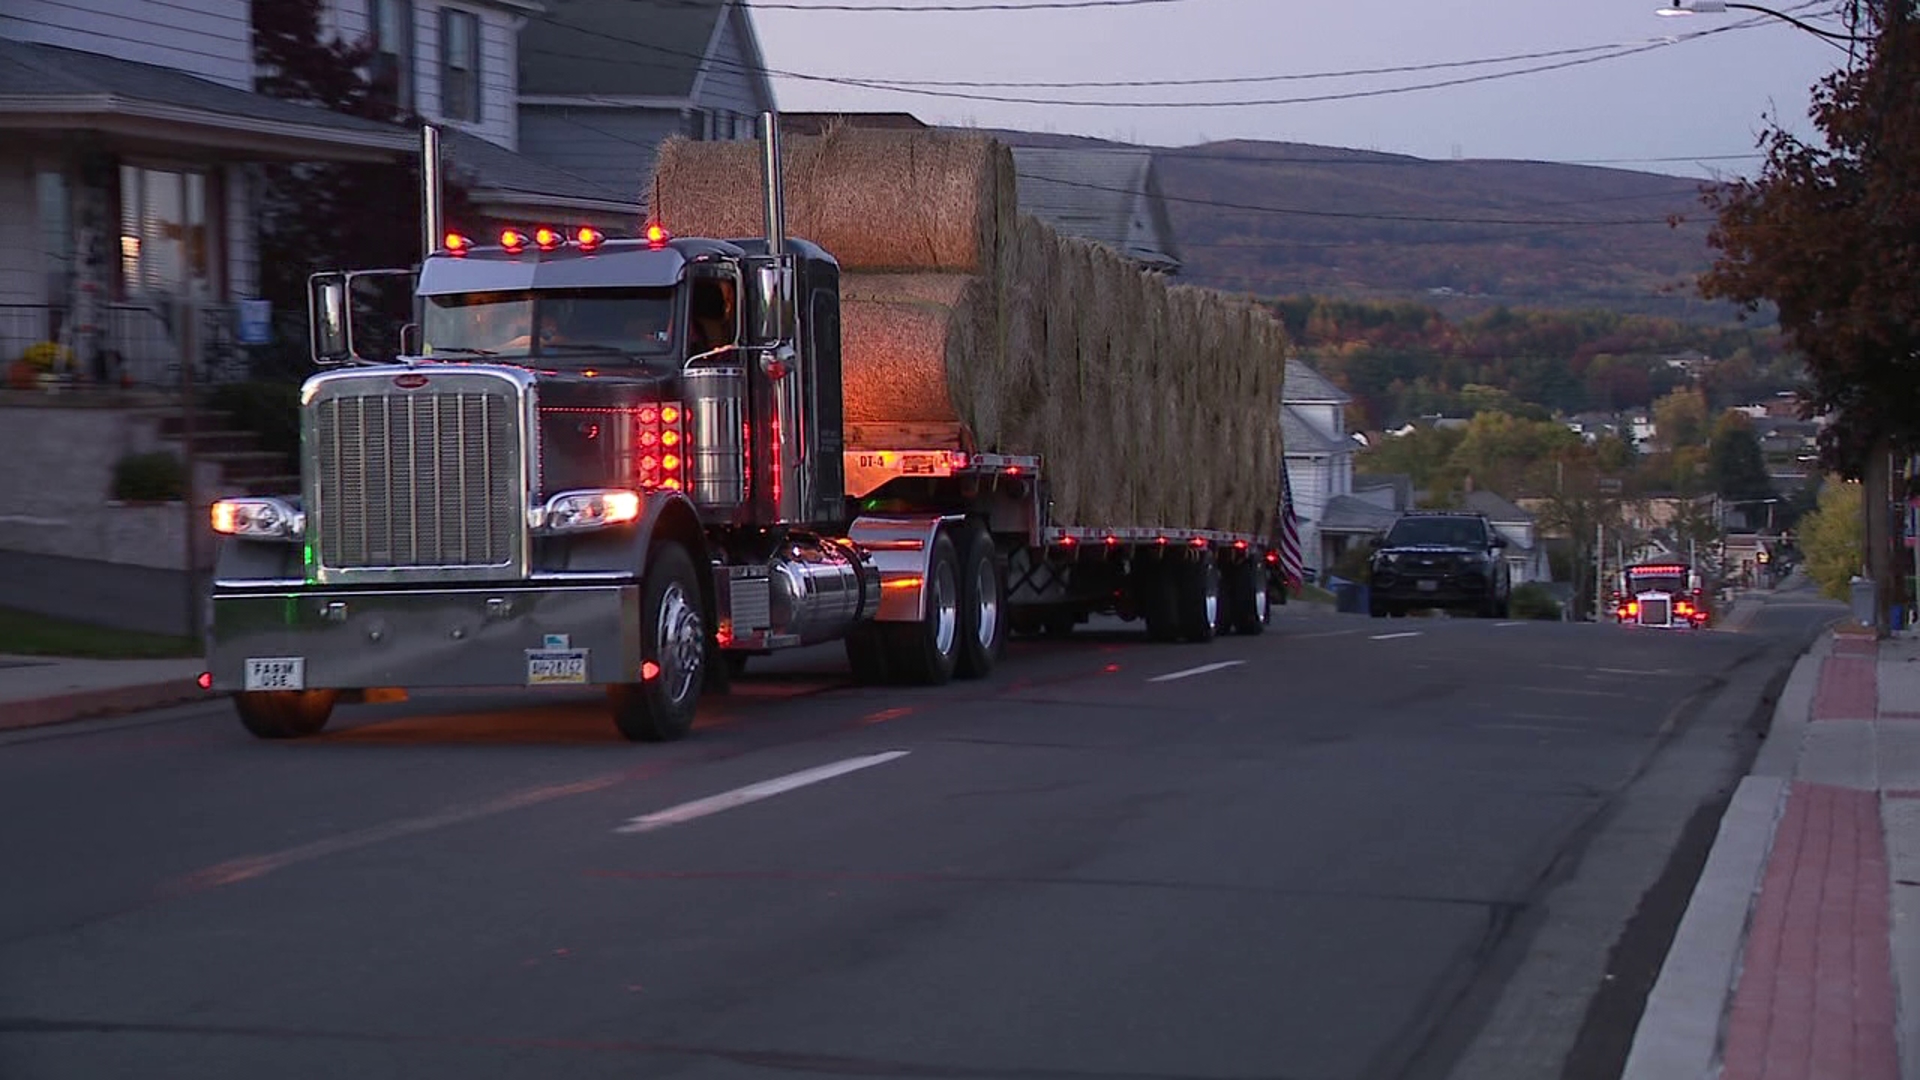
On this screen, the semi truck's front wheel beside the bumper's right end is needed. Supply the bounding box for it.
[607,540,707,742]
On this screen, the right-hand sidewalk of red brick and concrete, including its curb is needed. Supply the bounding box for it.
[1622,630,1920,1080]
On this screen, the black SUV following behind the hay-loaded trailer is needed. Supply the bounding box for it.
[1367,511,1513,619]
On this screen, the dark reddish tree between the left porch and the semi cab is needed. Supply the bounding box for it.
[252,0,467,369]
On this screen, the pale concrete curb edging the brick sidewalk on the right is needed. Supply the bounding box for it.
[1620,642,1826,1080]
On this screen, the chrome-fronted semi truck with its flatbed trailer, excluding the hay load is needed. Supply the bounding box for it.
[202,113,1284,742]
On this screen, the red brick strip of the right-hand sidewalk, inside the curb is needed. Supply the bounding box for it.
[1722,636,1916,1080]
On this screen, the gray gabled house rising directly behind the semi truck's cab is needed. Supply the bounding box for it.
[518,0,774,202]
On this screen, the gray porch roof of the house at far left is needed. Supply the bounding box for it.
[0,38,415,150]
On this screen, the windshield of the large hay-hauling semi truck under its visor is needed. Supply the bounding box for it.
[420,288,674,367]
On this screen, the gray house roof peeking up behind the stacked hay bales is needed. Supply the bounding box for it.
[1012,146,1181,271]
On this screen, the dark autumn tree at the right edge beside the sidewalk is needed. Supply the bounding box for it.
[1701,0,1920,634]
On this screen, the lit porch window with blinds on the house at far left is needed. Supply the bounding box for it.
[119,165,213,298]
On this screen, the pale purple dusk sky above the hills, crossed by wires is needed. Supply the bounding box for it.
[755,0,1847,175]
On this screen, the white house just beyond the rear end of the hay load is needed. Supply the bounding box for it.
[1281,357,1359,571]
